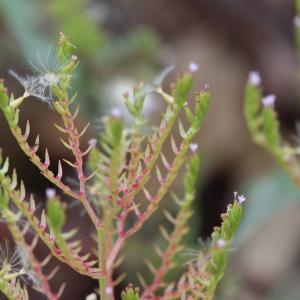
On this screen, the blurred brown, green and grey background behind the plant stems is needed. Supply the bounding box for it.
[0,0,300,300]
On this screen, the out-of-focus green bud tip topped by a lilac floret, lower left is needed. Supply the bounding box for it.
[47,198,66,233]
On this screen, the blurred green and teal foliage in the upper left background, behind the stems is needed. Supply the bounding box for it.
[0,0,160,118]
